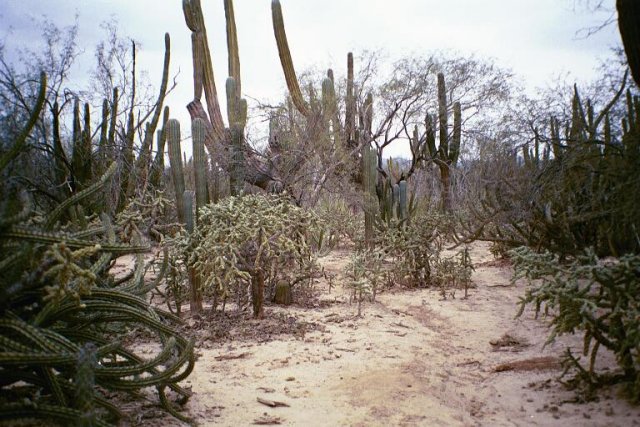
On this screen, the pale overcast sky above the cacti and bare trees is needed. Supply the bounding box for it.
[0,0,620,151]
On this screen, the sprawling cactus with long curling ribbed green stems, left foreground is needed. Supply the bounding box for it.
[0,76,194,426]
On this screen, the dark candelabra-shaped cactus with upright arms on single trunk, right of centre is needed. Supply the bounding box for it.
[425,73,462,211]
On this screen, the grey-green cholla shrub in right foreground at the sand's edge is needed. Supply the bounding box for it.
[510,247,640,402]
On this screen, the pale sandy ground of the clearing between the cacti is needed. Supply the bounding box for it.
[136,243,640,426]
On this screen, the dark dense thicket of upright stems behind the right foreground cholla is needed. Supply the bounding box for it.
[459,84,640,256]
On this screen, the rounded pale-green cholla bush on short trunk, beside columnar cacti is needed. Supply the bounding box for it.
[168,194,318,316]
